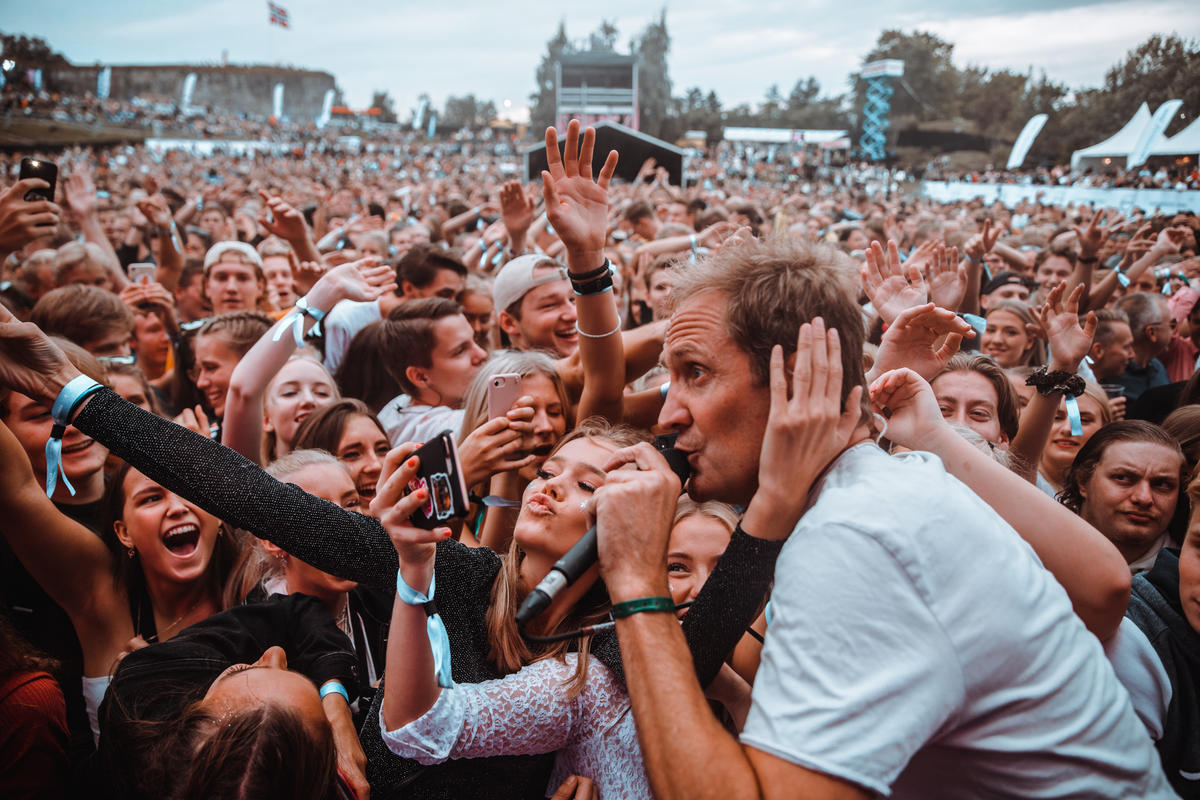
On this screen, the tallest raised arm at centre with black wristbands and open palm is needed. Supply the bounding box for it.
[541,120,625,422]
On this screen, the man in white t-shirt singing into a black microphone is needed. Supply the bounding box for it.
[595,241,1172,800]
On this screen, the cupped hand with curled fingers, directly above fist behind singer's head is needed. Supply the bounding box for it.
[870,302,974,380]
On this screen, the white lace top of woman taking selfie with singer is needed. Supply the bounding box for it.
[379,654,650,800]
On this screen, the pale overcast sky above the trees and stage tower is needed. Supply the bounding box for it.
[0,0,1200,122]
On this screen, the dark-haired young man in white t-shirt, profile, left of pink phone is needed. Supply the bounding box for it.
[379,297,487,446]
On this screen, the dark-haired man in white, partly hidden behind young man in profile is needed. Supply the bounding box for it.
[322,245,467,374]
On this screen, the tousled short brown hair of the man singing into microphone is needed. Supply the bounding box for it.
[670,236,870,420]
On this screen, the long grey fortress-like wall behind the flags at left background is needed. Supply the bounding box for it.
[46,65,336,122]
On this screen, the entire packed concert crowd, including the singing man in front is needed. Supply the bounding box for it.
[0,110,1200,800]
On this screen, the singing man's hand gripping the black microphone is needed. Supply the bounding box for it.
[588,443,682,602]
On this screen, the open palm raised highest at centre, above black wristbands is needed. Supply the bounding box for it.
[541,120,617,269]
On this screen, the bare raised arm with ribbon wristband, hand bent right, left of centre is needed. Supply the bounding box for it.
[222,258,396,463]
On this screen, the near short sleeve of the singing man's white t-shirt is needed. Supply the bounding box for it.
[742,522,964,794]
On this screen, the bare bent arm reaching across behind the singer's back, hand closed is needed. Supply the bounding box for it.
[871,367,1130,640]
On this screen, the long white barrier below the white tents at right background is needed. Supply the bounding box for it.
[920,181,1200,213]
